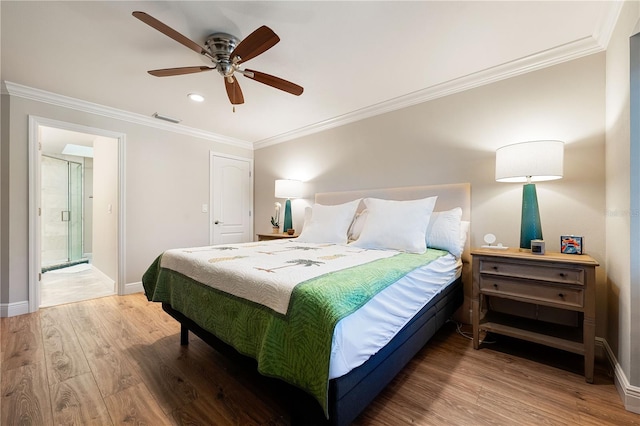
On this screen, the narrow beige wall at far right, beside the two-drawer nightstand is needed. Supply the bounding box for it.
[606,2,640,392]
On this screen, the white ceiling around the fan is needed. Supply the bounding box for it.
[0,0,620,147]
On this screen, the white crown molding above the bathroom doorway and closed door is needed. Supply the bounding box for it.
[2,81,253,150]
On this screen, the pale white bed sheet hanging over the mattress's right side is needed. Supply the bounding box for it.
[329,254,462,379]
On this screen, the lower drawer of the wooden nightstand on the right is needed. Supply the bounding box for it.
[480,276,584,308]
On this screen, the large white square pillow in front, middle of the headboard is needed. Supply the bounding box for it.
[351,197,437,253]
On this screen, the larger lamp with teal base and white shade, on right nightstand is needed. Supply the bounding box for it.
[496,141,564,249]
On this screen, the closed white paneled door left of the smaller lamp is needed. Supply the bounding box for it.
[209,153,253,244]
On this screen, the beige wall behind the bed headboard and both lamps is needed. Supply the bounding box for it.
[255,53,606,336]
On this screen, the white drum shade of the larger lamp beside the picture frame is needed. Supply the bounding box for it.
[496,141,564,182]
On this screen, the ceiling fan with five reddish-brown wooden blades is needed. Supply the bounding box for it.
[133,11,304,105]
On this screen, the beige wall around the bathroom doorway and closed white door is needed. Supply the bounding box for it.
[0,95,253,306]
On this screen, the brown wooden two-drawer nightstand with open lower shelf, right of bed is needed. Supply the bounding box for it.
[471,249,598,383]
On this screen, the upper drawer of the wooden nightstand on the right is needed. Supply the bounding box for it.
[480,260,584,285]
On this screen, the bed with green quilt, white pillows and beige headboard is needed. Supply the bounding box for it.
[143,184,470,425]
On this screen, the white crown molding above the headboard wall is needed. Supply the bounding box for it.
[253,33,604,149]
